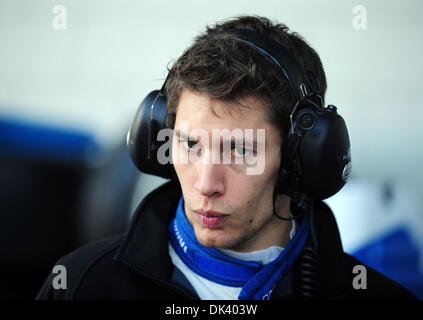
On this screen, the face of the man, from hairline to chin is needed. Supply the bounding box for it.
[172,89,292,251]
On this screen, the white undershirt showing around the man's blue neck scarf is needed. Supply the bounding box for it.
[169,220,296,300]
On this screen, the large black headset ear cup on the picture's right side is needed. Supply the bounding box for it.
[276,107,351,200]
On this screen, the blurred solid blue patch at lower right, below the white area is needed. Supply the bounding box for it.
[352,227,423,299]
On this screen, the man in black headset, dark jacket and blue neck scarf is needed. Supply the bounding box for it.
[37,16,413,299]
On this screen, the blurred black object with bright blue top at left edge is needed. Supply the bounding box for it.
[0,117,103,300]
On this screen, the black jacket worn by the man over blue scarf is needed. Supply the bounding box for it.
[36,181,414,300]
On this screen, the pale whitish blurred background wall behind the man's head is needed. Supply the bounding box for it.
[0,0,423,208]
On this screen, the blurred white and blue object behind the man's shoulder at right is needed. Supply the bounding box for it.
[325,178,423,299]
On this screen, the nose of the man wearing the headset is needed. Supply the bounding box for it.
[194,163,225,197]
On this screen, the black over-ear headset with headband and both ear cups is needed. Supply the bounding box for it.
[127,29,351,199]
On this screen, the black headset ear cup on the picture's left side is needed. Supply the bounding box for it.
[126,90,174,179]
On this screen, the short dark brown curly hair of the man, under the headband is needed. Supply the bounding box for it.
[165,16,326,140]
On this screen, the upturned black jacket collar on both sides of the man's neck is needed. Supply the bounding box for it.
[114,181,352,299]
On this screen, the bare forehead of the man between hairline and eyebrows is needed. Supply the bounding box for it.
[175,89,278,131]
